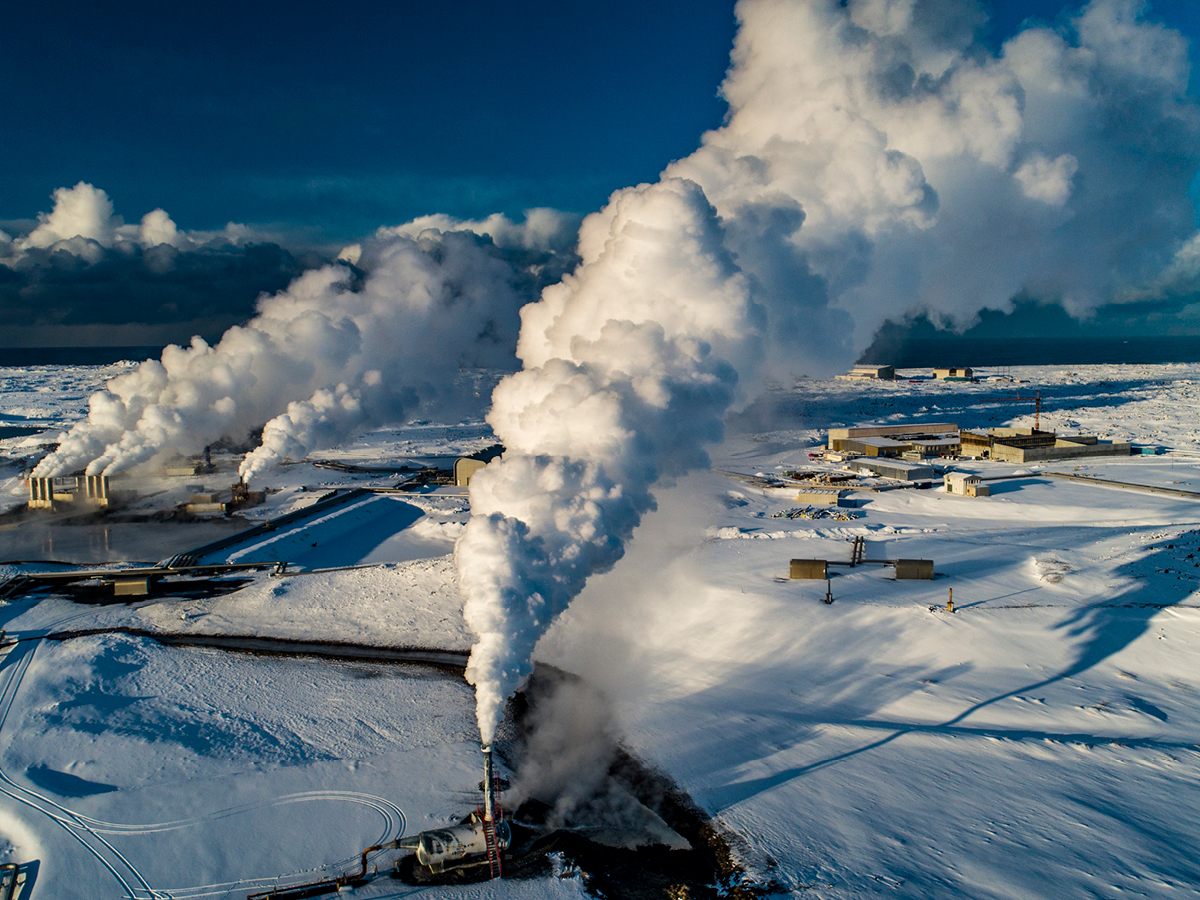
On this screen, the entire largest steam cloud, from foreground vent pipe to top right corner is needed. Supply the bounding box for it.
[457,0,1200,743]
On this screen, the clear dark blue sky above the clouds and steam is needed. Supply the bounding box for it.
[0,0,1200,241]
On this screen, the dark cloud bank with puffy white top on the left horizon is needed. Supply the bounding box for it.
[0,182,328,344]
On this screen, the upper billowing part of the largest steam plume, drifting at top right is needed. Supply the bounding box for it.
[667,0,1200,355]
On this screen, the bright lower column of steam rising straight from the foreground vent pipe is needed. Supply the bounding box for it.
[457,179,757,743]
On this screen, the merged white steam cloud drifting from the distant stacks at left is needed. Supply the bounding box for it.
[36,233,540,476]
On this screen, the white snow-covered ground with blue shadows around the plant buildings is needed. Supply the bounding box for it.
[0,366,1200,898]
